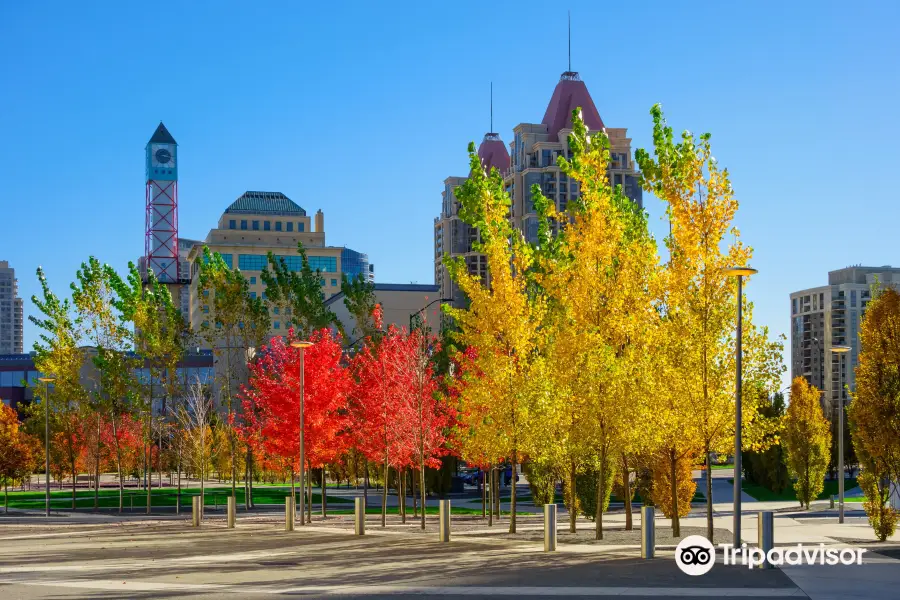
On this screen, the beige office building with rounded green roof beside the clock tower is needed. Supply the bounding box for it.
[187,192,370,335]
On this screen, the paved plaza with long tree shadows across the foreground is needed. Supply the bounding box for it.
[0,472,900,600]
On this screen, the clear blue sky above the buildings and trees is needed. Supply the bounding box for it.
[0,0,900,384]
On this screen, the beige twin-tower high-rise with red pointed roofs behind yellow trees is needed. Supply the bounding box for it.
[434,71,643,304]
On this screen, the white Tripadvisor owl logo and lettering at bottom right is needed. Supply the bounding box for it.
[675,535,867,575]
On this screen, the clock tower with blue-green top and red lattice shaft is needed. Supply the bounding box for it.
[144,122,178,283]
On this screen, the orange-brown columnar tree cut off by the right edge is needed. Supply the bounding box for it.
[848,287,900,541]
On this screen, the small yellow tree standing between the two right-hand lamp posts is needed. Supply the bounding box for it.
[782,377,831,509]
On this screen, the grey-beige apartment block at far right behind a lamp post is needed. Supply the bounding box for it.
[791,266,900,417]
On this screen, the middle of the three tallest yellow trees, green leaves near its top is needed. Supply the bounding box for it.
[531,109,659,539]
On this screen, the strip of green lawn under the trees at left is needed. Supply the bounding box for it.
[0,485,353,510]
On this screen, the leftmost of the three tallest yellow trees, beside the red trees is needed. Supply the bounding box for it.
[447,144,543,533]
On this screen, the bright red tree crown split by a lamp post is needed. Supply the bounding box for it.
[238,329,351,471]
